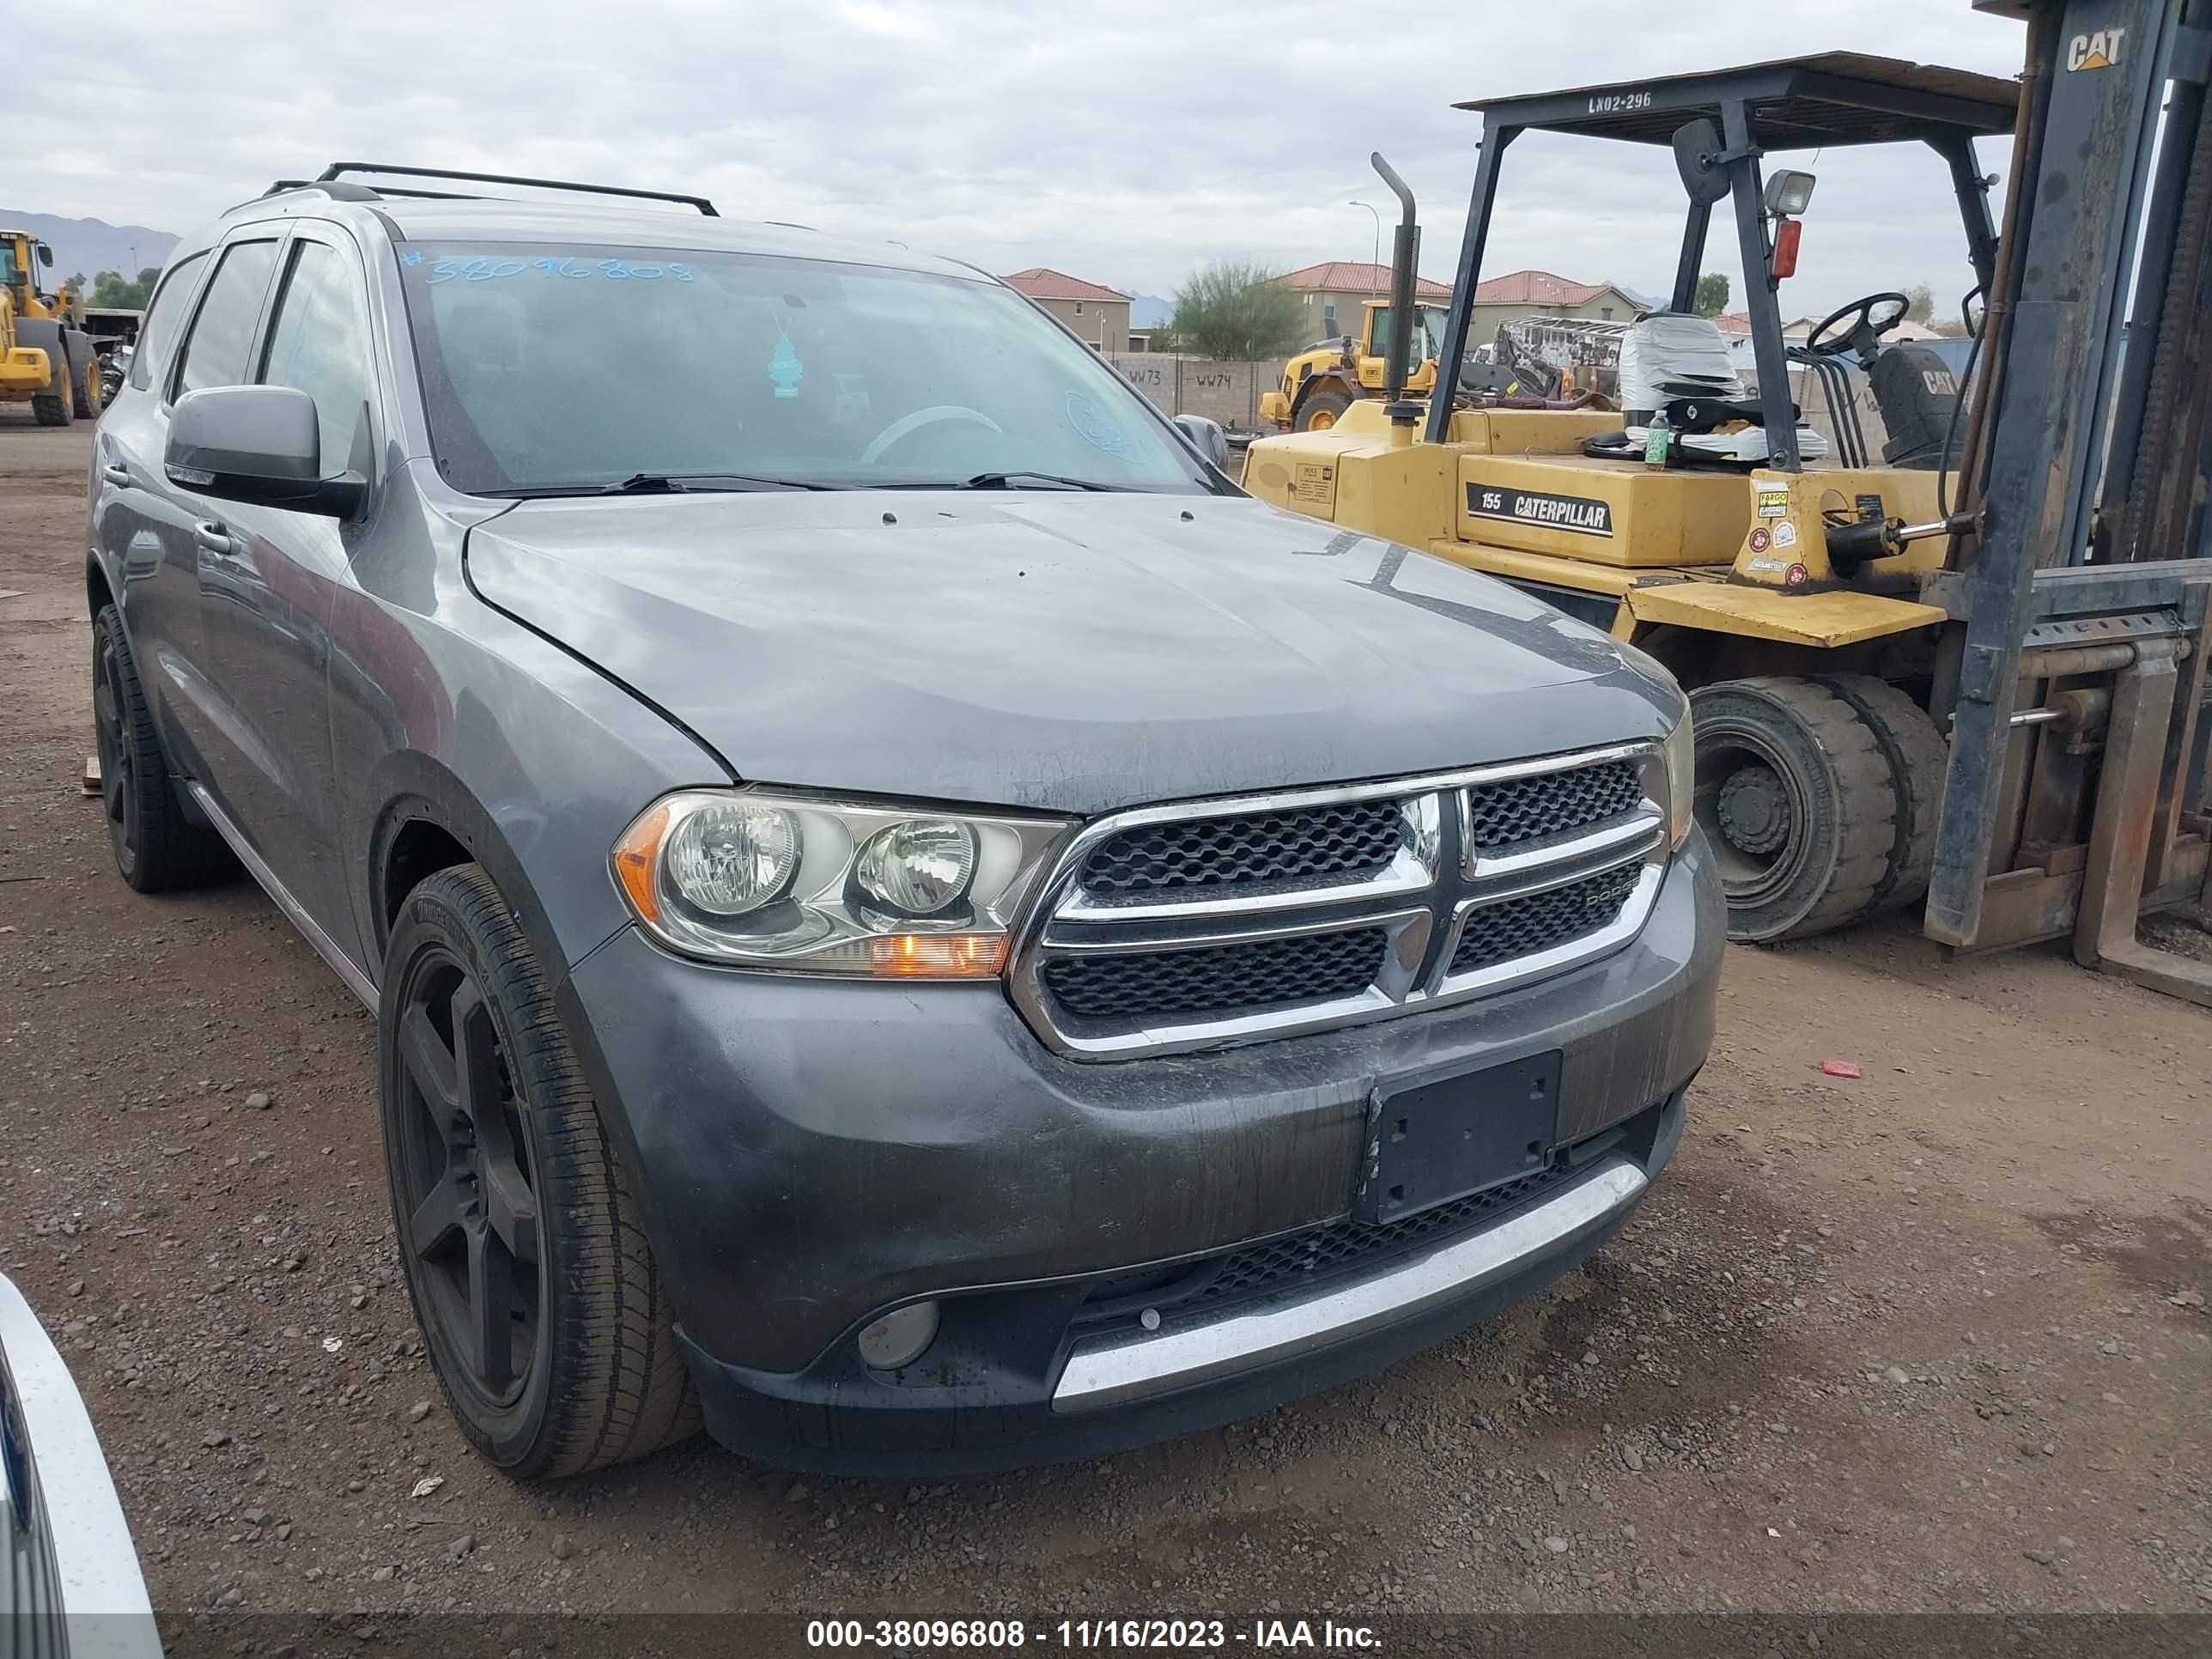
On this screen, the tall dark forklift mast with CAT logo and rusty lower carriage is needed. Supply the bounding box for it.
[1924,0,2212,1002]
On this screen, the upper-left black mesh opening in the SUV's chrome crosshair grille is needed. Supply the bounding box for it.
[1082,801,1405,900]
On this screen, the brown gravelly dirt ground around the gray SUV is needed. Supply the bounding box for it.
[0,416,2212,1620]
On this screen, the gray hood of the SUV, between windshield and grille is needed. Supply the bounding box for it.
[467,491,1681,814]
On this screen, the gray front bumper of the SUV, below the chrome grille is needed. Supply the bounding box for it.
[564,836,1723,1474]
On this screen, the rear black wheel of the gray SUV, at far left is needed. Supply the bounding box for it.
[93,604,237,894]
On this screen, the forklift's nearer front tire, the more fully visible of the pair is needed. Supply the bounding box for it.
[1690,675,1898,945]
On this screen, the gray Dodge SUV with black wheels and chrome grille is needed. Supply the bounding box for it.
[86,168,1723,1475]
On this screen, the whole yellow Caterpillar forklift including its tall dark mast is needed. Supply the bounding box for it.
[1245,0,2212,988]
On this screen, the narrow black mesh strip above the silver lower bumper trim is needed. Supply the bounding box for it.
[1078,1161,1575,1329]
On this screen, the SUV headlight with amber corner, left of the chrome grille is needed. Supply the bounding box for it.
[613,790,1071,980]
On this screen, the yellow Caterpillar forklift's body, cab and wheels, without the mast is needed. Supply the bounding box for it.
[1243,53,2020,940]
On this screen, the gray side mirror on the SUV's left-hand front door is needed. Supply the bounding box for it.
[161,385,369,518]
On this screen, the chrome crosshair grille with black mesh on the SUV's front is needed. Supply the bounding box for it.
[1011,744,1668,1060]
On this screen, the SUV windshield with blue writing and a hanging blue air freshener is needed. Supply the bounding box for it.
[400,243,1212,493]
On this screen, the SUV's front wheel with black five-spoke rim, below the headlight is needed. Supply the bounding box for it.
[376,865,699,1480]
